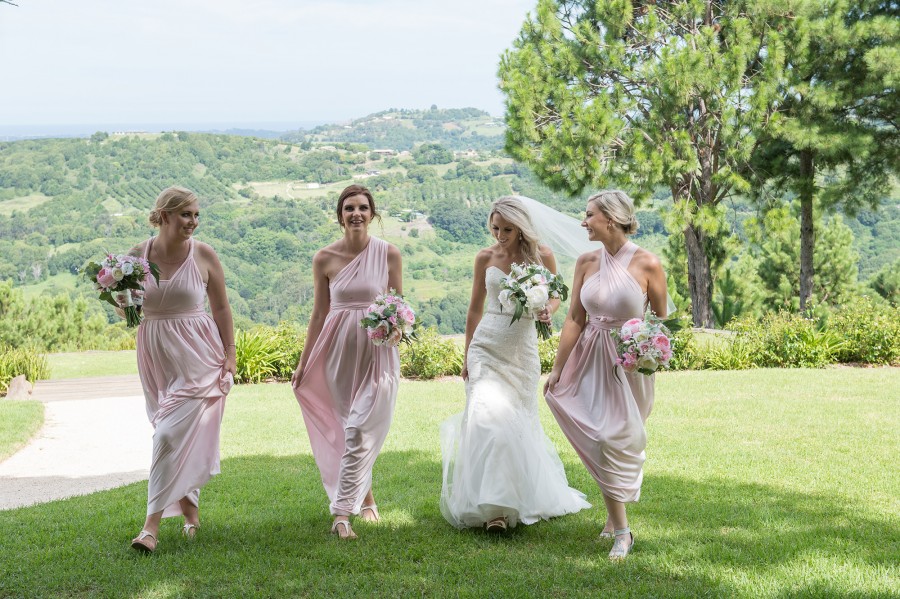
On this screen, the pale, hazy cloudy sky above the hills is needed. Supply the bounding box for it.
[0,0,537,129]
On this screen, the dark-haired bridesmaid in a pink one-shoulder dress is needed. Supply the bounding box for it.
[291,185,403,539]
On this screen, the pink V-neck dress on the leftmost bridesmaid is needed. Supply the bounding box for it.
[137,239,234,518]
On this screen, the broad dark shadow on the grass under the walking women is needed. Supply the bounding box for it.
[0,452,900,597]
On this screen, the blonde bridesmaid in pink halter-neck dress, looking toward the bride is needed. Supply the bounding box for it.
[544,191,667,559]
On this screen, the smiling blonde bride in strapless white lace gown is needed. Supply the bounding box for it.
[441,197,591,532]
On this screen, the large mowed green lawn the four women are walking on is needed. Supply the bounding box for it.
[0,368,900,597]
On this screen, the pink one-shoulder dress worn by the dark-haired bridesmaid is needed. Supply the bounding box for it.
[294,237,400,516]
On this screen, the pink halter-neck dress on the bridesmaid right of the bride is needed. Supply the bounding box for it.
[546,241,654,503]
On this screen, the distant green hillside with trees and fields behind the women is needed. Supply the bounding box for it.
[0,108,900,333]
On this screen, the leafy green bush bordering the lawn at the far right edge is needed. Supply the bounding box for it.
[828,297,900,364]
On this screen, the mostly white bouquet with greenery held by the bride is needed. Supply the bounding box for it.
[498,264,569,339]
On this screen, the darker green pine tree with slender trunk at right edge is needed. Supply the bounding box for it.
[753,0,900,309]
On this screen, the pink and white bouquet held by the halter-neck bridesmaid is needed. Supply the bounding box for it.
[612,309,677,376]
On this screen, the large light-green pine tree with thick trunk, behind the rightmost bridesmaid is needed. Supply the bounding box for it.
[499,0,783,327]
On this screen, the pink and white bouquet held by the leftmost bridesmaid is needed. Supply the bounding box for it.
[83,254,159,327]
